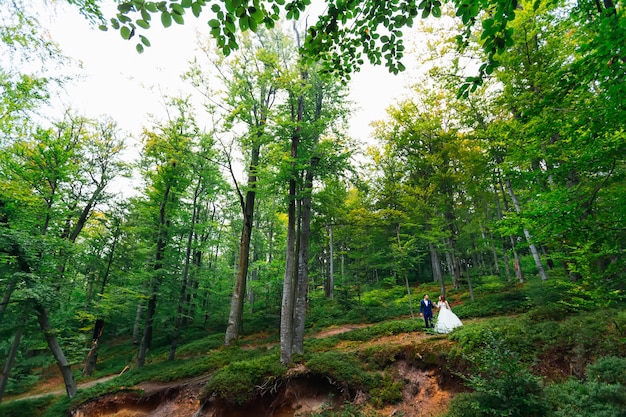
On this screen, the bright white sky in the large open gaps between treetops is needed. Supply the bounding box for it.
[42,2,411,148]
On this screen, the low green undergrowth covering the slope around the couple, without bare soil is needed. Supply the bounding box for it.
[0,277,626,417]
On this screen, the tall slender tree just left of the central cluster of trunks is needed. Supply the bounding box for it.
[187,31,292,346]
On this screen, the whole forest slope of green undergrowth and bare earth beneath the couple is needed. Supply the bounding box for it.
[6,278,626,417]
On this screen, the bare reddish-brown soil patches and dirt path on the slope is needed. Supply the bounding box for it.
[8,317,461,417]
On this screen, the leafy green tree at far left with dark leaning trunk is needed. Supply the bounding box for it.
[0,114,123,397]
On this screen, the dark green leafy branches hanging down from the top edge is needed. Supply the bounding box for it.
[90,0,518,81]
